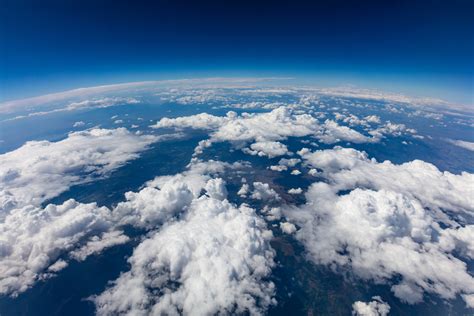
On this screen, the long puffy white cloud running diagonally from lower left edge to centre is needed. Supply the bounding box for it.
[0,160,252,295]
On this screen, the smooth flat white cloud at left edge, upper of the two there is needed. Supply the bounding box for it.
[0,128,158,207]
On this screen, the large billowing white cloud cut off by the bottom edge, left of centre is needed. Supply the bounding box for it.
[94,184,274,315]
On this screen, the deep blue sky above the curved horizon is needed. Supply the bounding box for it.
[0,0,474,104]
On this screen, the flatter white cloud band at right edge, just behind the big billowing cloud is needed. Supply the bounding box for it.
[300,147,474,214]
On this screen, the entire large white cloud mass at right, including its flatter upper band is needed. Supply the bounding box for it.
[284,148,474,304]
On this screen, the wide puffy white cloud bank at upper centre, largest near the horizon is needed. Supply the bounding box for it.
[152,107,378,154]
